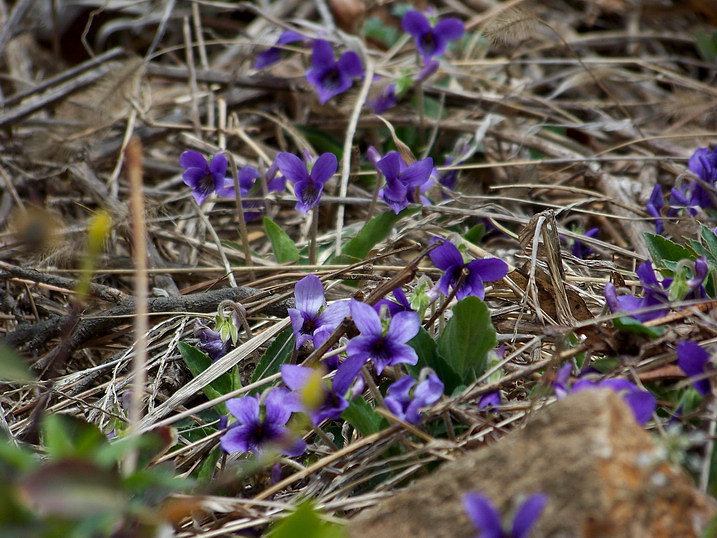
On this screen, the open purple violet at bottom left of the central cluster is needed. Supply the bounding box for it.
[221,388,306,456]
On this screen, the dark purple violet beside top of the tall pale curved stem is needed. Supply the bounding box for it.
[306,39,364,105]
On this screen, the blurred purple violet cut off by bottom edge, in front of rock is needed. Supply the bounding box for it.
[463,491,548,538]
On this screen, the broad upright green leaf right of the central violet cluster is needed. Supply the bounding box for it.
[438,296,498,383]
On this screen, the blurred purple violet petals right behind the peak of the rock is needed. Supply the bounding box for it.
[553,364,657,426]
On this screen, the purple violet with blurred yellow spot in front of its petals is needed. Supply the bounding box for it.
[281,357,365,425]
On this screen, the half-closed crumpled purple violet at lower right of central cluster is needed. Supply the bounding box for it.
[383,373,443,424]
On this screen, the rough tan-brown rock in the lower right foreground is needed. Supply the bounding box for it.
[349,390,715,538]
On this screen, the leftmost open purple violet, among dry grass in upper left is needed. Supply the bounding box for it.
[179,150,234,205]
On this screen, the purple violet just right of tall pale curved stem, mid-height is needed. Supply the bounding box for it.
[376,151,433,214]
